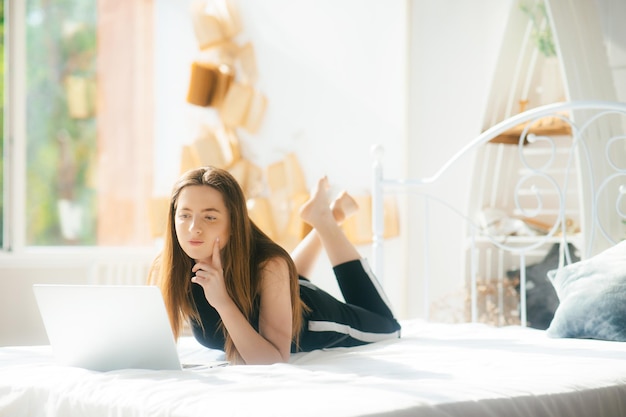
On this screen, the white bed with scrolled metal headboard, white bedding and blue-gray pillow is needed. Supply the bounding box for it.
[0,102,626,417]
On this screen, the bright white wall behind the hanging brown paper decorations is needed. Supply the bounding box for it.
[155,0,407,195]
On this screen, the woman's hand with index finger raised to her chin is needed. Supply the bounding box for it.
[191,238,232,311]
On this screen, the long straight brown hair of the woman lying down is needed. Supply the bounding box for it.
[150,167,306,362]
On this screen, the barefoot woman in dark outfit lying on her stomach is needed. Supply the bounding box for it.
[151,167,400,364]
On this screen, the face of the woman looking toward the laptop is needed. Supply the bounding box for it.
[174,185,230,261]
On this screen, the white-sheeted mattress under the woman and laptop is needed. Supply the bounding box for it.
[0,321,626,417]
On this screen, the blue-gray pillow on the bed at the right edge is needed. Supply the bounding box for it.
[547,241,626,342]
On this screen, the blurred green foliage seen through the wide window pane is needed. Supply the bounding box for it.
[26,0,97,245]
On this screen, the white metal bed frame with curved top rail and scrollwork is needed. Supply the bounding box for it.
[372,101,626,326]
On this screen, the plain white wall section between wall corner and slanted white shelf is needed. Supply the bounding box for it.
[406,0,512,317]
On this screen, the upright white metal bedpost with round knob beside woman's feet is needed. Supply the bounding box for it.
[371,145,385,283]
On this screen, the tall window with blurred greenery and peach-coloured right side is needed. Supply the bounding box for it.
[5,0,153,248]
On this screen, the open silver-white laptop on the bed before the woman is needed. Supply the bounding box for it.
[33,284,188,371]
